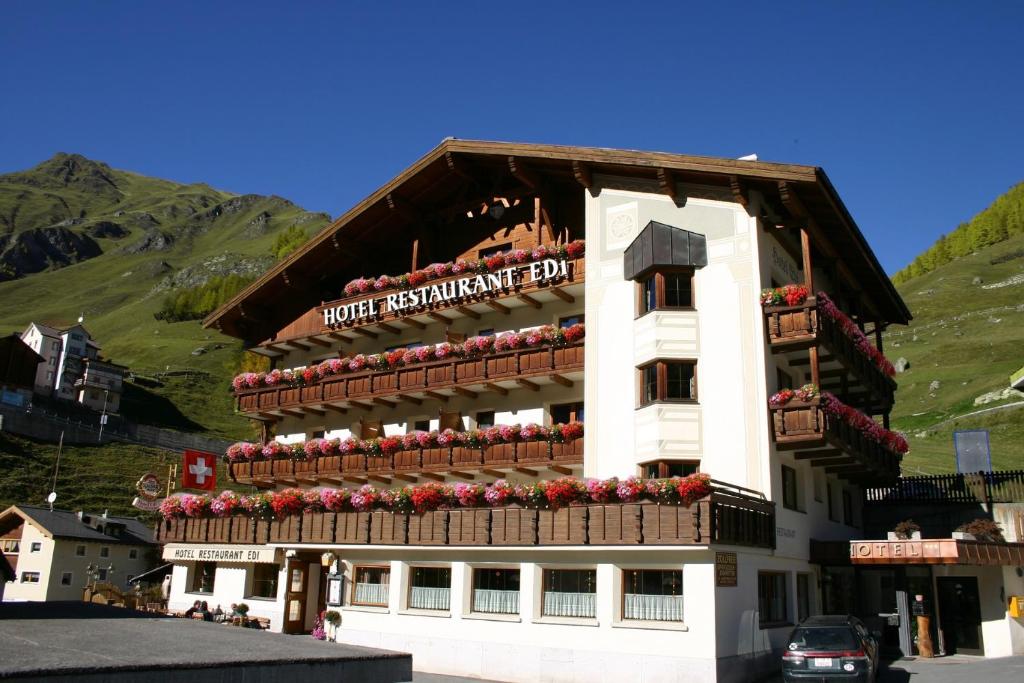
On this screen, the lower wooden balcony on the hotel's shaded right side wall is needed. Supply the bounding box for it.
[769,398,901,485]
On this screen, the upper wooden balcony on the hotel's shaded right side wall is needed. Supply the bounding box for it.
[764,297,896,415]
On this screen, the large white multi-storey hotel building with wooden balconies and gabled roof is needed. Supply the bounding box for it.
[158,139,910,681]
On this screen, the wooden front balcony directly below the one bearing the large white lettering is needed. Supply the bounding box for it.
[236,341,584,417]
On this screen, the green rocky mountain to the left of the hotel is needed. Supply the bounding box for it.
[0,154,330,438]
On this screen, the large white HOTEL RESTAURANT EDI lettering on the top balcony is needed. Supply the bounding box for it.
[324,258,568,328]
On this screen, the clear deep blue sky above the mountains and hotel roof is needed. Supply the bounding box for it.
[0,0,1024,271]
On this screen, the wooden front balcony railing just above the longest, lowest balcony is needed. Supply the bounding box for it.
[227,438,584,488]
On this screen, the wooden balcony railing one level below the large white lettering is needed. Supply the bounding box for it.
[236,342,584,414]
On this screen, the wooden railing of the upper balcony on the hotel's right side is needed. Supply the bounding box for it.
[764,297,896,412]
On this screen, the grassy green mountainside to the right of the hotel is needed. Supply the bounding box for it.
[885,184,1024,474]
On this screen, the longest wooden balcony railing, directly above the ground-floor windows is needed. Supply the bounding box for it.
[156,490,775,548]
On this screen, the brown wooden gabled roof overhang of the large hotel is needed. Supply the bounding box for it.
[203,138,910,342]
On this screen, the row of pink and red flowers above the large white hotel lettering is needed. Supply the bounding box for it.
[342,240,586,297]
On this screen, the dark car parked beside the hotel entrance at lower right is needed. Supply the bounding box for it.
[782,614,879,683]
